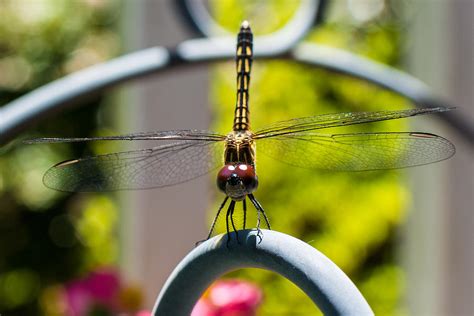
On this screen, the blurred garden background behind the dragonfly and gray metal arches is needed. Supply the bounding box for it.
[0,0,474,315]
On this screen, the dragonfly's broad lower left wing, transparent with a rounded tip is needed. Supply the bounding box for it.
[43,141,224,192]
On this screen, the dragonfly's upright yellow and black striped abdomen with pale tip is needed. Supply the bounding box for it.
[234,21,253,131]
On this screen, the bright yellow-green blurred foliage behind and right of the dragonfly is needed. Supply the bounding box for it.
[209,0,411,315]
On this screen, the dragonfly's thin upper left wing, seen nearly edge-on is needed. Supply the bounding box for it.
[24,130,225,144]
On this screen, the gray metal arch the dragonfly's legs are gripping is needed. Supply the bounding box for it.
[153,230,373,316]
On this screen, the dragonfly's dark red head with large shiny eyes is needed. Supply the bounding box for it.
[217,163,258,200]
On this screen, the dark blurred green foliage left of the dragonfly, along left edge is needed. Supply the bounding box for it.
[0,0,120,315]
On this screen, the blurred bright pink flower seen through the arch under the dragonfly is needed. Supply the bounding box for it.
[191,280,262,316]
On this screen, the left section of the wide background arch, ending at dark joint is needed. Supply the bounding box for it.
[0,47,170,144]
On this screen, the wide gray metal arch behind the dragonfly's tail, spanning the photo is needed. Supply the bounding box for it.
[0,38,474,144]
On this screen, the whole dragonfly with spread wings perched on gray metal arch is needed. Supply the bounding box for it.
[28,21,455,239]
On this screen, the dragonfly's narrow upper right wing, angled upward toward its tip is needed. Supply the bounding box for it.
[254,107,450,139]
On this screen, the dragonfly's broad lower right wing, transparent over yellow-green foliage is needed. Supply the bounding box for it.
[257,133,455,171]
